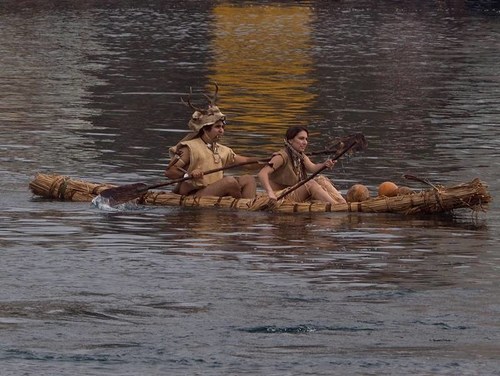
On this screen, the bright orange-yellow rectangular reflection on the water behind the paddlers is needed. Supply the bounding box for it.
[207,4,316,149]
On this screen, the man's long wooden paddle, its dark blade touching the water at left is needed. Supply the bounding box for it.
[100,136,364,206]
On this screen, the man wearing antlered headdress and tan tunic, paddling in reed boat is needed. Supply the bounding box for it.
[165,85,258,198]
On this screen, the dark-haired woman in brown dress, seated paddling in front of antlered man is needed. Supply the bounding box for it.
[258,126,346,205]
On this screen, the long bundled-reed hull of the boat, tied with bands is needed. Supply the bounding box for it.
[29,173,492,215]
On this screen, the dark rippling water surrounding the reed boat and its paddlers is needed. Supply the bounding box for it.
[0,1,500,375]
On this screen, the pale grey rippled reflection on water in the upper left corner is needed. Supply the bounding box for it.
[0,13,105,180]
